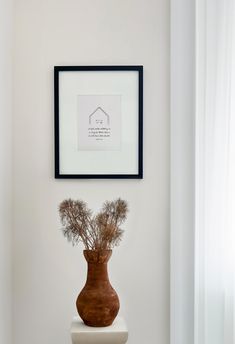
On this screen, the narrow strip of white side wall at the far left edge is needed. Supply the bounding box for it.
[0,0,13,344]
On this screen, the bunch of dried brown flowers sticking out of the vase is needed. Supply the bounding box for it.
[59,198,128,250]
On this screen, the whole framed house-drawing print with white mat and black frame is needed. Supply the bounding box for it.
[54,66,143,179]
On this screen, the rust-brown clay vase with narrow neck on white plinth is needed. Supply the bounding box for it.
[76,250,119,327]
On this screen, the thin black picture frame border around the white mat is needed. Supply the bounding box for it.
[54,65,143,179]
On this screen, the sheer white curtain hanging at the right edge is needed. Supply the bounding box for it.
[195,0,235,344]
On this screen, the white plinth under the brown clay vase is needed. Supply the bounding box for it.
[71,317,128,344]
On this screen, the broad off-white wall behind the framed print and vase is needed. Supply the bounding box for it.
[13,0,169,344]
